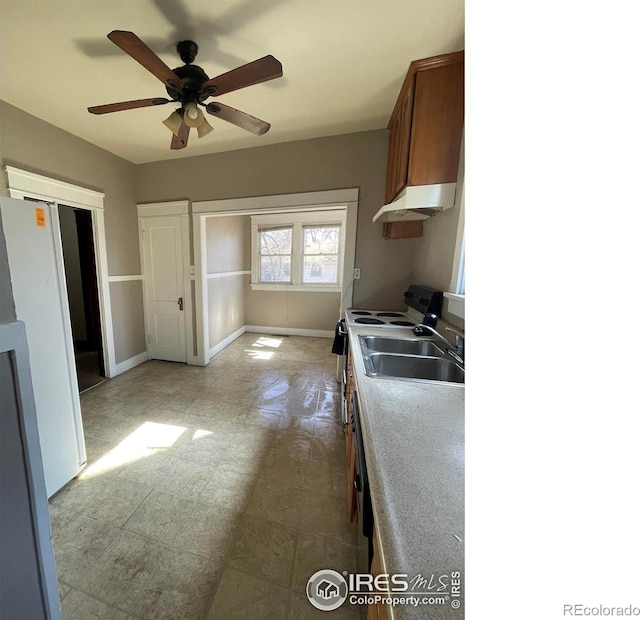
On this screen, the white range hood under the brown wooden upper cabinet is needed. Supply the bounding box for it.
[373,183,456,222]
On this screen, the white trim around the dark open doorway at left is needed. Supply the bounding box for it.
[4,166,118,378]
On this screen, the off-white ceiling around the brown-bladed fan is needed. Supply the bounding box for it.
[0,0,464,163]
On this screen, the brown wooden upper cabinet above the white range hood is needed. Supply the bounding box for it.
[385,51,464,204]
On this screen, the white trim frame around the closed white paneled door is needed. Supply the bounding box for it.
[137,200,194,365]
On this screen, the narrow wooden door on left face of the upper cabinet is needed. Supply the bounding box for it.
[385,84,414,204]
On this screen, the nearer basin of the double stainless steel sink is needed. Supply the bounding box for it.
[365,353,464,383]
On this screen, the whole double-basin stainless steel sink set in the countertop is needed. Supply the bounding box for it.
[358,336,464,384]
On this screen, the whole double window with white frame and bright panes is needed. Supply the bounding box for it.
[251,209,346,292]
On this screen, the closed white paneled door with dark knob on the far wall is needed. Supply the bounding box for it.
[140,216,187,362]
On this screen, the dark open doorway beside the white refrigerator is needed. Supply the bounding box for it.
[58,205,105,392]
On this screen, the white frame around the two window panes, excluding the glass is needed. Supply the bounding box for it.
[251,209,347,293]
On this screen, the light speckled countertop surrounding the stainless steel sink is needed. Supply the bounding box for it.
[349,323,465,620]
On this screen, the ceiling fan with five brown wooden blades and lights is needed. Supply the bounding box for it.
[87,30,282,149]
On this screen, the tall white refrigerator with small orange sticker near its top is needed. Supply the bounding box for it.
[0,198,86,497]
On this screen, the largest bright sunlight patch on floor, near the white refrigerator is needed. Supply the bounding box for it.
[78,422,187,480]
